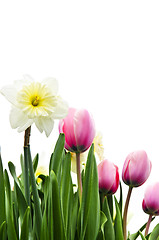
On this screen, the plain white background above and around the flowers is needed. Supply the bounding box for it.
[0,0,159,235]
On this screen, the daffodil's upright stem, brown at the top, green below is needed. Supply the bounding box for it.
[24,127,31,205]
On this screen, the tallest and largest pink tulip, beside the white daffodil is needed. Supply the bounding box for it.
[59,108,95,152]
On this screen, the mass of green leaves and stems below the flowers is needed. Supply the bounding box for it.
[0,134,159,240]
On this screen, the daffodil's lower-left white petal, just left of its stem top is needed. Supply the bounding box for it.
[10,107,33,132]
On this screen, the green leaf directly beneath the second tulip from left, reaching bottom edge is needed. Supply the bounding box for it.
[103,197,115,240]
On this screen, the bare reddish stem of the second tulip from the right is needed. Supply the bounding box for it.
[123,187,133,240]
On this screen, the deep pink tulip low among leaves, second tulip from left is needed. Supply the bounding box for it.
[98,160,119,195]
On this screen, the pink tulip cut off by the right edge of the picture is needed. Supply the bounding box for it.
[142,182,159,216]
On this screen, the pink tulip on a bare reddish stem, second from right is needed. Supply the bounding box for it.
[122,151,151,187]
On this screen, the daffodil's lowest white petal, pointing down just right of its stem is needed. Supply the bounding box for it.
[34,117,54,137]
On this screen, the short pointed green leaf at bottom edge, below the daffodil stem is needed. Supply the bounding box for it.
[20,207,30,240]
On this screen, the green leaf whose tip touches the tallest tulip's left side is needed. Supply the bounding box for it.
[49,133,65,175]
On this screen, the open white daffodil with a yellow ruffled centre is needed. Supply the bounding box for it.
[0,75,68,137]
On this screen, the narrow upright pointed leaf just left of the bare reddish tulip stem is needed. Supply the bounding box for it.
[114,197,124,240]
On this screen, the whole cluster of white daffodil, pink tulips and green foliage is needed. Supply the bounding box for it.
[0,76,159,240]
